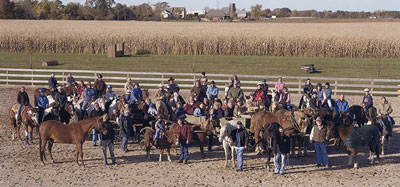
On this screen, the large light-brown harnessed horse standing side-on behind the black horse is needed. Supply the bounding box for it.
[250,110,310,154]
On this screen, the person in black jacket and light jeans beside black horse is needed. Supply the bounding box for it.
[273,127,290,175]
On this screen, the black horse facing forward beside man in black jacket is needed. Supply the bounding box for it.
[262,122,280,169]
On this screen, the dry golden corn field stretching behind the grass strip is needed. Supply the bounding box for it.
[0,20,400,58]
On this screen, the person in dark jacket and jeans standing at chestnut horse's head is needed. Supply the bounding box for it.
[100,115,116,165]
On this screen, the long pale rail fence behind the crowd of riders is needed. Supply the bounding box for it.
[0,68,400,96]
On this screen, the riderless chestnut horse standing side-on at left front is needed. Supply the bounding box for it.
[39,115,107,167]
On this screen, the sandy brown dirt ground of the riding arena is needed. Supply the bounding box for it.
[0,86,400,186]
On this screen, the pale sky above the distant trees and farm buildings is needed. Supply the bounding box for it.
[61,0,400,11]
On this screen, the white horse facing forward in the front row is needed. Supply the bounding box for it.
[219,120,237,167]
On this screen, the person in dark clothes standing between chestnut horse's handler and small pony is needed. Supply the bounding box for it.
[119,110,133,152]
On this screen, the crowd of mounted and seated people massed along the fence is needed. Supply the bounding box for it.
[16,72,392,171]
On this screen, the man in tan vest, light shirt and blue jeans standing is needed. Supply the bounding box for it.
[310,117,329,168]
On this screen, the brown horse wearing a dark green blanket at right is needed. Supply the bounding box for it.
[327,123,379,168]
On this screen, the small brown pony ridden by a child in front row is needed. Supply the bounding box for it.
[142,127,179,162]
